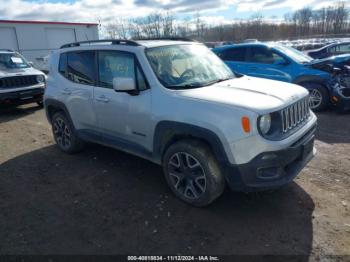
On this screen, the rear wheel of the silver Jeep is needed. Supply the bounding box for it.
[52,112,84,154]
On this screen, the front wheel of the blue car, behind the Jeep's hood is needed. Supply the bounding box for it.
[301,83,329,112]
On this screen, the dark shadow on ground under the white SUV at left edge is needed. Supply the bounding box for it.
[0,104,42,124]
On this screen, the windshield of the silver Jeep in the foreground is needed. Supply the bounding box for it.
[146,44,234,89]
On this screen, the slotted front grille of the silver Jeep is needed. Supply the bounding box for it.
[281,97,310,134]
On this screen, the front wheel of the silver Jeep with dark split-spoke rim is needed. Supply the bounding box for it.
[163,140,225,207]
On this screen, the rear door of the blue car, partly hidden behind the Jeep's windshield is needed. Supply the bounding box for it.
[218,47,247,74]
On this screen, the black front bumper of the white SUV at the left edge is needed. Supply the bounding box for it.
[0,88,45,108]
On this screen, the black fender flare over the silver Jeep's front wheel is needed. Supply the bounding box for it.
[153,121,228,163]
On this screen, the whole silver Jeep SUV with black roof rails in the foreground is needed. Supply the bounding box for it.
[44,39,316,206]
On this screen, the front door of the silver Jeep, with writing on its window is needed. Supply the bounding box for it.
[94,50,151,149]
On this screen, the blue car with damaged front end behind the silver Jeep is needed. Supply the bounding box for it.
[212,43,350,111]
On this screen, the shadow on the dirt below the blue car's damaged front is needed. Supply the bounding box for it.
[316,111,350,144]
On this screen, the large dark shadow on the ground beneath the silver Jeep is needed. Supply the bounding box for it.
[0,145,314,261]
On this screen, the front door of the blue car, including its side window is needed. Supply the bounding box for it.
[246,46,292,82]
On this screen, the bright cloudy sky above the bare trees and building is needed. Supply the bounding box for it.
[0,0,350,25]
